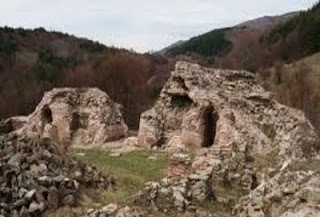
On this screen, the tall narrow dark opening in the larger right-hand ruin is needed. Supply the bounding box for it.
[203,106,219,147]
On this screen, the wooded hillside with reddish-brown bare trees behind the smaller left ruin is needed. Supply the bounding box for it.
[0,27,170,127]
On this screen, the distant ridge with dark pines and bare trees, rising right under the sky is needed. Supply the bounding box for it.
[162,2,320,72]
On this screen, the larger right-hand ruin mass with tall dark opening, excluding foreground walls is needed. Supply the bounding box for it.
[138,62,319,189]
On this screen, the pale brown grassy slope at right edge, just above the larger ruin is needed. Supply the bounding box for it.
[257,53,320,135]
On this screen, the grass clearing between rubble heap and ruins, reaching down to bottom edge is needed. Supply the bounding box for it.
[45,150,168,217]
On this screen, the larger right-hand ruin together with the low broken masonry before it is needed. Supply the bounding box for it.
[138,62,320,217]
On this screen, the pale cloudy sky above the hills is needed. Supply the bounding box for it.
[0,0,317,52]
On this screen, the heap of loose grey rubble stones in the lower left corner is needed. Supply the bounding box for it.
[0,134,109,217]
